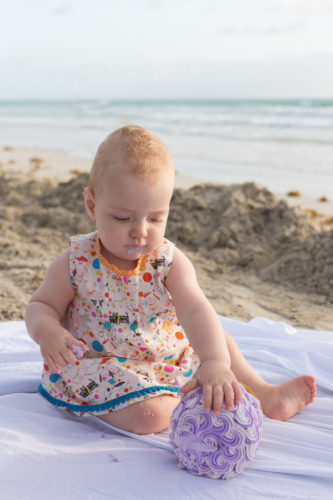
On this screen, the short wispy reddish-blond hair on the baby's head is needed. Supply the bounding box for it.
[89,125,174,191]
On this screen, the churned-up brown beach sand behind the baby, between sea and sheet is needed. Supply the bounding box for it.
[0,145,333,330]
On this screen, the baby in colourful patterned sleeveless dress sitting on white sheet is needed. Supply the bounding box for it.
[26,125,316,434]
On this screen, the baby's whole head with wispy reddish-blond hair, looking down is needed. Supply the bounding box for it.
[85,125,175,269]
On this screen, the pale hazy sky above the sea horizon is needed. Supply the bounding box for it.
[0,0,333,100]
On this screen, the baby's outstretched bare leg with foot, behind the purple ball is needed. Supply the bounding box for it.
[226,334,316,420]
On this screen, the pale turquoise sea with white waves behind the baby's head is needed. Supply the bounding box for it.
[0,99,333,200]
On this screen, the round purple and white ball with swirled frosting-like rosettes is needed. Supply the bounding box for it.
[170,384,263,479]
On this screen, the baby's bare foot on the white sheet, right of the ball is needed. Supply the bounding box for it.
[260,375,316,420]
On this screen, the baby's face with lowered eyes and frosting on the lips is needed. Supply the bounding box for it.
[85,169,174,269]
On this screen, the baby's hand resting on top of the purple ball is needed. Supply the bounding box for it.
[180,360,242,415]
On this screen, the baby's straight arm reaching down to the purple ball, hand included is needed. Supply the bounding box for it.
[166,248,241,414]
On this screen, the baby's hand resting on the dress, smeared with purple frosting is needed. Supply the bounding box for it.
[39,327,87,372]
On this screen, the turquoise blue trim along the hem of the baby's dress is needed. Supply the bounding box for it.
[38,384,179,413]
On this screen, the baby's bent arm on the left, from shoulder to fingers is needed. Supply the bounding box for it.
[25,250,86,372]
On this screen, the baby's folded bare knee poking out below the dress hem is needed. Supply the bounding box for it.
[99,394,180,434]
